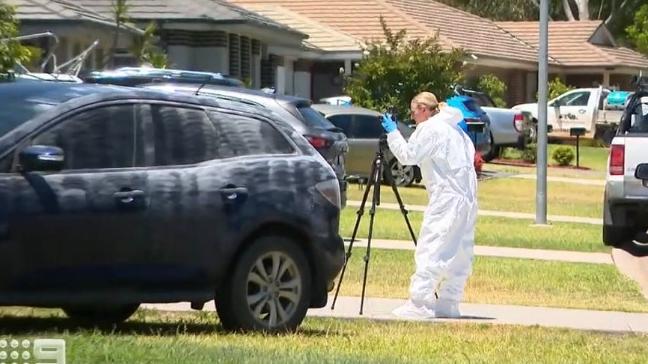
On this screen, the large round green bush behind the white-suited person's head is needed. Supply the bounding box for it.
[345,17,464,119]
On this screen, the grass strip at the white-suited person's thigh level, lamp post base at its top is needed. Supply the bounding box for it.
[340,207,610,252]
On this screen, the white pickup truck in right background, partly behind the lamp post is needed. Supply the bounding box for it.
[512,87,623,132]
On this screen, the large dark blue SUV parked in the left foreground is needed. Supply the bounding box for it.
[0,81,344,331]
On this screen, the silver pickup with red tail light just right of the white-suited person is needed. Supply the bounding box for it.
[455,87,532,162]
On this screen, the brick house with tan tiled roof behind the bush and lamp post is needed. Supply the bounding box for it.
[230,0,648,105]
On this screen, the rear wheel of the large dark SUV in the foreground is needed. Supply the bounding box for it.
[216,235,311,332]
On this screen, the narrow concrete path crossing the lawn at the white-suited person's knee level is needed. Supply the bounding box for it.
[344,237,614,264]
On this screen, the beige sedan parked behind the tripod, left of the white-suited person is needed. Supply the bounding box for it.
[313,104,421,186]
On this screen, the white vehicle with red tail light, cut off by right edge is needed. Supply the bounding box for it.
[603,78,648,249]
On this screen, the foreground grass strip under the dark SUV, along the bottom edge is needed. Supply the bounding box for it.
[0,310,648,364]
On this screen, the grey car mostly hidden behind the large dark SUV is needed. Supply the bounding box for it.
[145,84,349,206]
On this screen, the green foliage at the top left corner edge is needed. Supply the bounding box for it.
[0,2,31,75]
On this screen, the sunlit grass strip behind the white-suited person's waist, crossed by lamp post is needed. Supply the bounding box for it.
[347,178,604,218]
